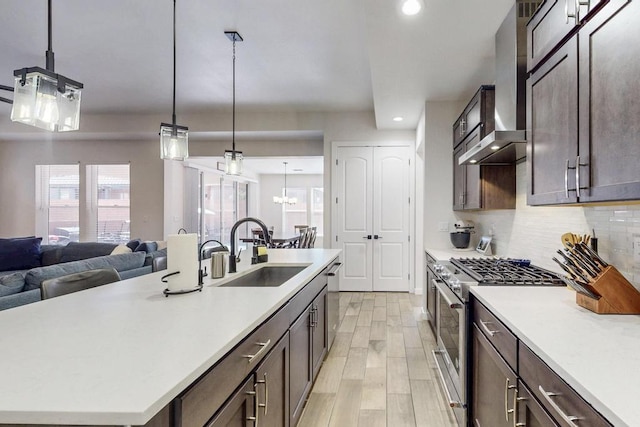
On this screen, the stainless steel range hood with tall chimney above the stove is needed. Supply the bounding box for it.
[459,1,540,165]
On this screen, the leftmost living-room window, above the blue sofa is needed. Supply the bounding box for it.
[36,164,80,245]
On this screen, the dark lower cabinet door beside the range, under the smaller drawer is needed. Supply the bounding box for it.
[470,324,518,427]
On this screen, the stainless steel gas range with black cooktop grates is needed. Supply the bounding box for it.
[427,258,564,426]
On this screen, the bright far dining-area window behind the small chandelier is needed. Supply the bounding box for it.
[282,187,324,235]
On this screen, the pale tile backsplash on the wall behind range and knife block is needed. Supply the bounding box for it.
[456,163,640,289]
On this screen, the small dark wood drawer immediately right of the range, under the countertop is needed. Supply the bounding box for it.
[473,299,518,372]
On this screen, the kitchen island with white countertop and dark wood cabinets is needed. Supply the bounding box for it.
[0,249,339,427]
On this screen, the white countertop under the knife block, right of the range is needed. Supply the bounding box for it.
[471,286,640,427]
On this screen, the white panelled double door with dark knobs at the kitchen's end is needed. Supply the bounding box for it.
[333,146,411,292]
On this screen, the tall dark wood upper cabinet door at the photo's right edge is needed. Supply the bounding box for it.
[576,0,640,202]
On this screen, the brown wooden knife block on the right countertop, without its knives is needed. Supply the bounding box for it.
[576,265,640,314]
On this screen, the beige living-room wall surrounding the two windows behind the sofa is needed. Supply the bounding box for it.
[0,140,164,240]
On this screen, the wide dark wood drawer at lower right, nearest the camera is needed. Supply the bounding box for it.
[518,342,611,427]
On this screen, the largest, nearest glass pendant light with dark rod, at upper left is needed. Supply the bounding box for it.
[11,0,84,132]
